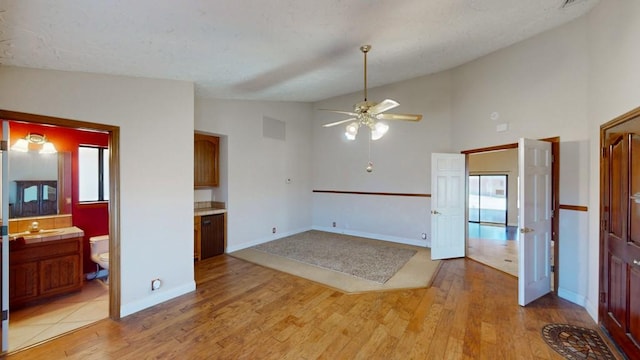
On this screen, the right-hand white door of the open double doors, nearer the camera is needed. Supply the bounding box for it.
[518,139,553,306]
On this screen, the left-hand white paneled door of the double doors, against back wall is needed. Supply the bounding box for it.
[431,153,466,260]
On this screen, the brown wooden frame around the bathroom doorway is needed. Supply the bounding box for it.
[0,109,120,320]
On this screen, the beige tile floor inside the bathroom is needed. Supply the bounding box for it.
[9,280,109,352]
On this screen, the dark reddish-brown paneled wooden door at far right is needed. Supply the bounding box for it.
[599,109,640,359]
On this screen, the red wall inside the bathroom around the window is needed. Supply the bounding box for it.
[9,121,109,273]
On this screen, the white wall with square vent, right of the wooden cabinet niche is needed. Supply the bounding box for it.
[195,99,311,252]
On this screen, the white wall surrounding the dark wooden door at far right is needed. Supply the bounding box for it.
[587,0,640,316]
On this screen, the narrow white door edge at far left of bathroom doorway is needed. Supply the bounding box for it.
[0,120,9,353]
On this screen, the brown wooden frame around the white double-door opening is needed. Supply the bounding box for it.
[460,136,560,294]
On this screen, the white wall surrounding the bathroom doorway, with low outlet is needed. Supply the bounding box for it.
[0,67,195,316]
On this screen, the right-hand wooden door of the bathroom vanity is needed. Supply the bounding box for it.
[39,255,81,295]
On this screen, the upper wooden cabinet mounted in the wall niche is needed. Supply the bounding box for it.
[193,133,220,189]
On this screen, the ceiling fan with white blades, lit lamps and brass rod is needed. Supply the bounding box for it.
[320,45,422,140]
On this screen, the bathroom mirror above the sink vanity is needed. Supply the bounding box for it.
[9,151,71,218]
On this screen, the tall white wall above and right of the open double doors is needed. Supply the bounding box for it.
[444,18,597,306]
